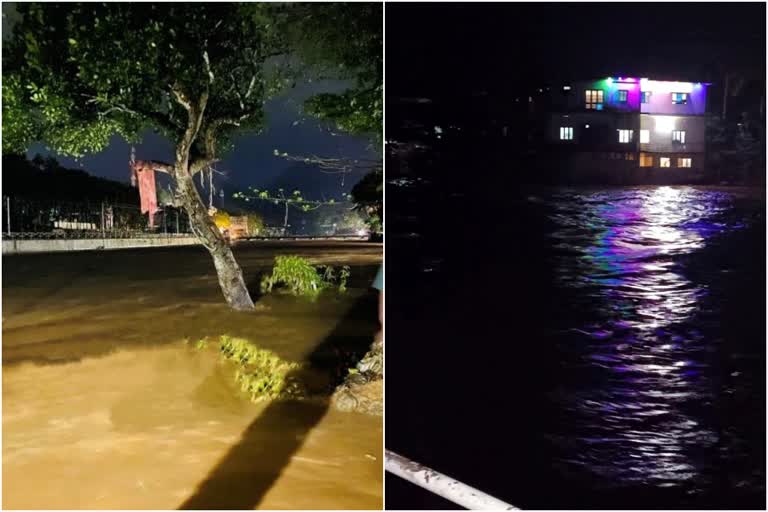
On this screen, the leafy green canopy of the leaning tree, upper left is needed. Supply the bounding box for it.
[3,2,287,166]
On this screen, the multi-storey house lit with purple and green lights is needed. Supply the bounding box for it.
[547,77,709,179]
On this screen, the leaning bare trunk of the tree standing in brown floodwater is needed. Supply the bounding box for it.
[174,168,253,311]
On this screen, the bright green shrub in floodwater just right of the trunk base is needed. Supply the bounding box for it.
[261,256,349,297]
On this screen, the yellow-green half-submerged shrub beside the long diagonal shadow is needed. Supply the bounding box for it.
[219,336,301,402]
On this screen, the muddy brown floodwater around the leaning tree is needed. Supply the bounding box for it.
[2,242,383,509]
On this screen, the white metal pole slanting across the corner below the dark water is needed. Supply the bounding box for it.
[384,450,518,510]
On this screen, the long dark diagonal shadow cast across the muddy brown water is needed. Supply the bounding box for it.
[179,293,376,510]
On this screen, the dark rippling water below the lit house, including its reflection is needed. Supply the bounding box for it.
[386,187,765,509]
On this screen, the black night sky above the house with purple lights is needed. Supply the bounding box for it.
[386,2,766,96]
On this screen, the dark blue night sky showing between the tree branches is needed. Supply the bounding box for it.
[3,2,380,198]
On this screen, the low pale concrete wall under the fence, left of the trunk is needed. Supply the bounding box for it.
[3,236,199,254]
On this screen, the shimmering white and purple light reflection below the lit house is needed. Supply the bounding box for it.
[552,187,740,488]
